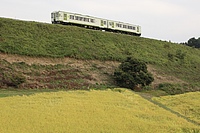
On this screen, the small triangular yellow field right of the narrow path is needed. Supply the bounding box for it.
[153,92,200,124]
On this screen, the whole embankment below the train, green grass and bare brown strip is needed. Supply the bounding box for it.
[0,18,200,94]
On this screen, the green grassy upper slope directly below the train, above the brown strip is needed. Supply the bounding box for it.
[0,18,200,92]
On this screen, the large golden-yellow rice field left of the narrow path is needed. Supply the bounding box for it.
[0,89,200,133]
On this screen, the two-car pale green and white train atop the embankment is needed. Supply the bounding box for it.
[51,11,141,36]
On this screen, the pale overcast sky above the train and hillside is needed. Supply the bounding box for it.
[0,0,200,43]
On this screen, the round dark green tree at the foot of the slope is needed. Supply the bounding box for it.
[114,57,154,90]
